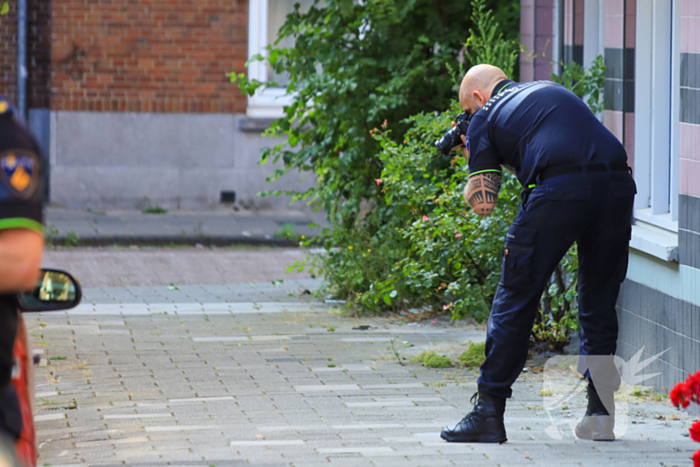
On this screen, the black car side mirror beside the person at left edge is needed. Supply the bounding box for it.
[17,269,83,311]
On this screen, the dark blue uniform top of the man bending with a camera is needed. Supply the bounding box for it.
[467,80,627,187]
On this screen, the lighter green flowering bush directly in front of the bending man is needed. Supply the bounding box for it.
[366,107,519,321]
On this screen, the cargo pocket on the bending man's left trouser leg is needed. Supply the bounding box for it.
[501,224,537,289]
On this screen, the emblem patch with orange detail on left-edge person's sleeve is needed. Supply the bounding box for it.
[0,149,41,199]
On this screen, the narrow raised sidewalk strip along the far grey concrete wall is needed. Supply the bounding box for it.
[45,207,327,246]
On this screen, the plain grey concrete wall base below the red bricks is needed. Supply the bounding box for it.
[49,111,311,209]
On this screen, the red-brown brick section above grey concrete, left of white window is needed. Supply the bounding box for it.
[51,0,248,112]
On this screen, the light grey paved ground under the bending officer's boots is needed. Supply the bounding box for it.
[26,279,696,467]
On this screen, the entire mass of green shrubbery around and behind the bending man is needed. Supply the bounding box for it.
[231,0,603,348]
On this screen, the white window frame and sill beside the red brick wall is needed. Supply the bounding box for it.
[246,0,293,118]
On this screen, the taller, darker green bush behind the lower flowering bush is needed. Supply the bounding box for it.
[230,0,519,218]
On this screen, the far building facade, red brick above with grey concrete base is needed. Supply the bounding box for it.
[0,0,308,208]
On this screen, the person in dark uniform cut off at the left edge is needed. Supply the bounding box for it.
[0,96,44,440]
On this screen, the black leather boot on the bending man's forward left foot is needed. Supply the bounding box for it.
[440,392,508,443]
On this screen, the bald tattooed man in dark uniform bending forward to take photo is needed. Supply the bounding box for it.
[441,65,636,443]
